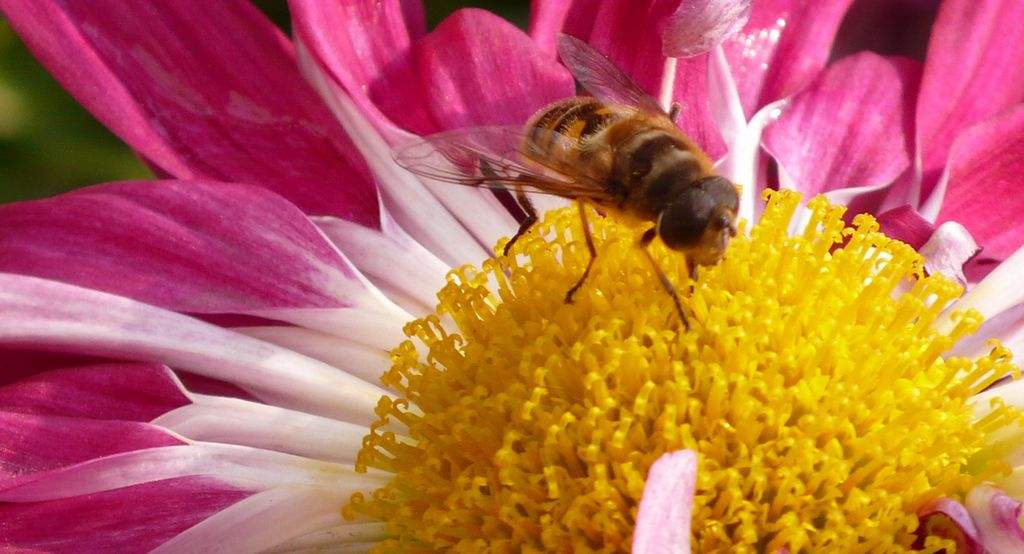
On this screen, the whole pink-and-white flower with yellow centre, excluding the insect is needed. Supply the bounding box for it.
[0,0,1024,553]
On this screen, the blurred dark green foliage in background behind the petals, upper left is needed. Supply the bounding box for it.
[0,0,529,202]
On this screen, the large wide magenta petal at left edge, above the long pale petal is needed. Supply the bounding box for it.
[0,181,376,313]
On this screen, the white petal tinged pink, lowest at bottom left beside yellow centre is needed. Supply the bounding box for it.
[154,486,351,554]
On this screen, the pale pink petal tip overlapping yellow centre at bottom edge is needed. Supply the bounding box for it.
[633,451,697,554]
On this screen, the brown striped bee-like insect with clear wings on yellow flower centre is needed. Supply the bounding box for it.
[395,35,739,327]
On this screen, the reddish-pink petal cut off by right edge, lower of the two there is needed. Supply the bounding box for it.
[922,107,1024,260]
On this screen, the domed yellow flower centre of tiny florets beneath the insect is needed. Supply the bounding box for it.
[343,193,1022,553]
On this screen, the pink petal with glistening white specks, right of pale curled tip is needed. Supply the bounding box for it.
[723,0,853,114]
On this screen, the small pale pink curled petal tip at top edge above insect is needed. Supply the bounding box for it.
[662,0,752,57]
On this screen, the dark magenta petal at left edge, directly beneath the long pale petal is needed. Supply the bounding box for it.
[0,364,190,422]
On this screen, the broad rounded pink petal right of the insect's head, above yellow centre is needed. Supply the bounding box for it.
[764,52,921,197]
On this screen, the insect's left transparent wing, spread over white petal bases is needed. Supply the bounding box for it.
[394,127,611,201]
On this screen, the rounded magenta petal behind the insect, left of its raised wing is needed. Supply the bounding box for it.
[415,9,575,129]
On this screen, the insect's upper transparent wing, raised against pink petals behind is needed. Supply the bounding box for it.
[558,35,665,114]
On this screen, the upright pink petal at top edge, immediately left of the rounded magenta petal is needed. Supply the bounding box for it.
[289,0,437,136]
